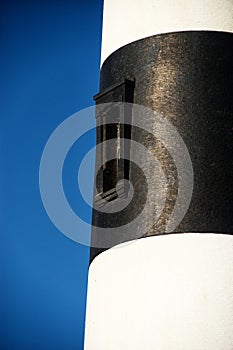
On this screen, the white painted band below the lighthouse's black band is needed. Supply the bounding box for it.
[85,233,233,350]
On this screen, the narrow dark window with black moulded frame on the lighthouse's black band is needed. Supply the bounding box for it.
[94,79,135,201]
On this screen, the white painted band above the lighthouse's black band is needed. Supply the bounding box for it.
[101,0,233,63]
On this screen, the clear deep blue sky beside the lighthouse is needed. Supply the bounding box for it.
[0,0,102,350]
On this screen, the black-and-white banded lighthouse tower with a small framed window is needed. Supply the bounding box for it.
[85,0,233,350]
